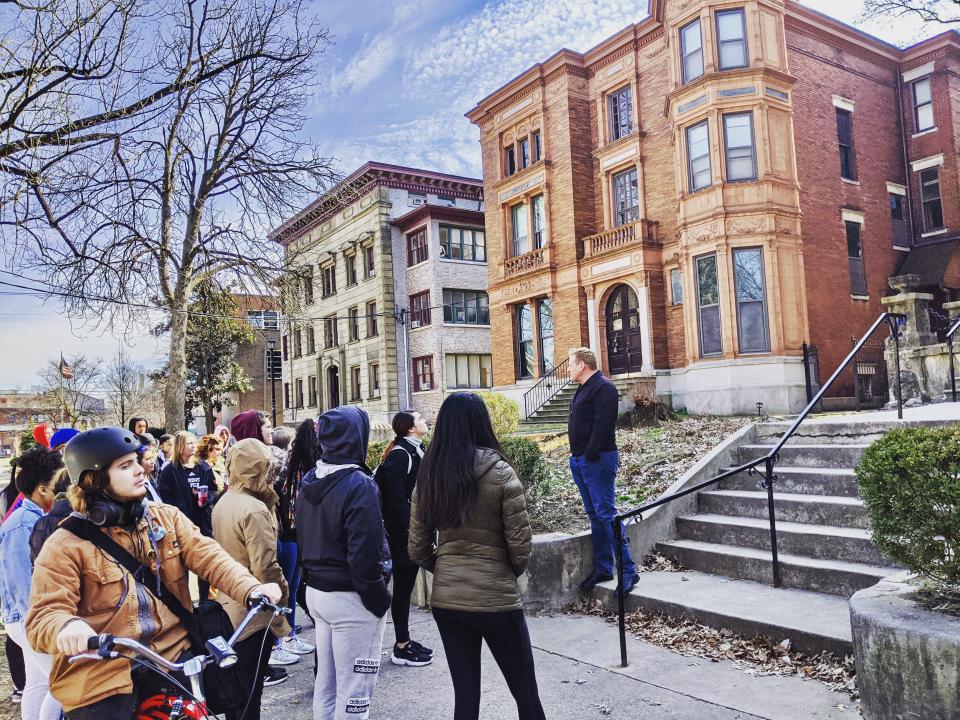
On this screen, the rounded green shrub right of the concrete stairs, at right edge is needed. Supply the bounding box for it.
[857,426,960,592]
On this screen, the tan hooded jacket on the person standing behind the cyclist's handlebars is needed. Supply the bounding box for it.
[213,438,290,640]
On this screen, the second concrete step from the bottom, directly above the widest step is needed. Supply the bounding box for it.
[656,540,894,597]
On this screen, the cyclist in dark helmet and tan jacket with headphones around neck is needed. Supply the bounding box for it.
[26,427,282,720]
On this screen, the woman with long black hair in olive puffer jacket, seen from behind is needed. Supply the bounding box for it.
[408,392,545,720]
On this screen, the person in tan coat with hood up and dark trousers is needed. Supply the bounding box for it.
[213,438,290,720]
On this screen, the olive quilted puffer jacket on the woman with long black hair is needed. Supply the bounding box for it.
[407,448,532,612]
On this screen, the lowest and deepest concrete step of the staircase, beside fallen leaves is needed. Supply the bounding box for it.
[595,571,852,657]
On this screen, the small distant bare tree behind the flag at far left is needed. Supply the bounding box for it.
[37,355,106,427]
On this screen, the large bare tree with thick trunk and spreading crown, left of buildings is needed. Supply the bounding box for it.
[2,0,338,430]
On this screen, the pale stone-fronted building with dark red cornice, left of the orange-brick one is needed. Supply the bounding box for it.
[271,162,490,428]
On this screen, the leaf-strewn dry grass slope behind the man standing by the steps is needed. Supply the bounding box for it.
[527,416,754,533]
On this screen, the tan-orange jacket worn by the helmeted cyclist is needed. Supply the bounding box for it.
[26,503,260,712]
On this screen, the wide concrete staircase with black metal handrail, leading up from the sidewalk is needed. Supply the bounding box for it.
[603,422,897,655]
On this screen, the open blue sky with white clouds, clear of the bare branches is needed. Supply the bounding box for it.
[0,0,924,390]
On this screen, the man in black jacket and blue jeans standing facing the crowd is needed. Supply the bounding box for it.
[567,348,638,592]
